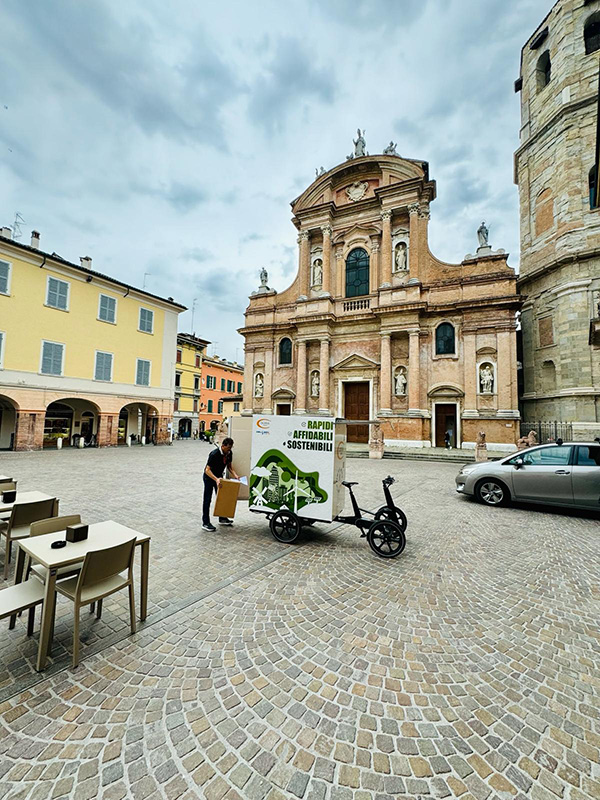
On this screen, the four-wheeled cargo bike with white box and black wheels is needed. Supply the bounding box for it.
[248,415,408,558]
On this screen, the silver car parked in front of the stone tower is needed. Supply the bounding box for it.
[456,442,600,511]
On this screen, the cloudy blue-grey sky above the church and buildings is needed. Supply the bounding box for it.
[0,0,552,361]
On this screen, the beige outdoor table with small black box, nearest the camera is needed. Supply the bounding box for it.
[15,520,150,672]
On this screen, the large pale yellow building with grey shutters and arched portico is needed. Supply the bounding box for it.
[0,228,185,450]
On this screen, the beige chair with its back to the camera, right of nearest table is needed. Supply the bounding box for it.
[56,539,136,667]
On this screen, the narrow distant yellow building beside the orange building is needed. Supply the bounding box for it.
[173,333,210,439]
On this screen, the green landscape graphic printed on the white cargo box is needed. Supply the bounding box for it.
[250,450,327,512]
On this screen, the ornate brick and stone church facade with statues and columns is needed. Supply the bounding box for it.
[240,138,520,448]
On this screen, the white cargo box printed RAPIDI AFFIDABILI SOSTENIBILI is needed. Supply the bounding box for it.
[248,414,346,522]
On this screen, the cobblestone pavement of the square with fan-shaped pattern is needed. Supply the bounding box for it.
[0,442,600,800]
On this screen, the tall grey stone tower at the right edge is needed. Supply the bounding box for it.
[515,0,600,438]
